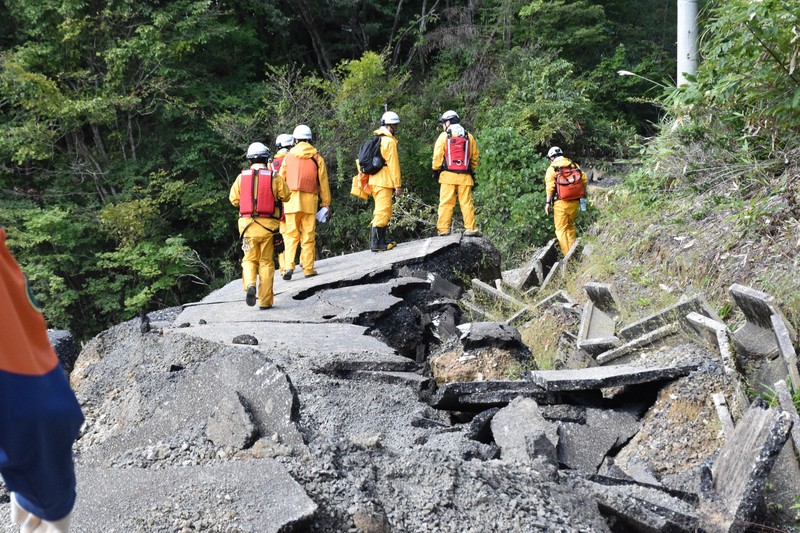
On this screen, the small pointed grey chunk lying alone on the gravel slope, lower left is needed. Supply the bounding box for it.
[206,391,258,450]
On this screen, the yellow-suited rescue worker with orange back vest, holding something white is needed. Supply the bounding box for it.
[279,124,331,281]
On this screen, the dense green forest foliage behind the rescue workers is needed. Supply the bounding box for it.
[0,0,675,337]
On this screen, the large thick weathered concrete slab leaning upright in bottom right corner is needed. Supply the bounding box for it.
[711,398,792,532]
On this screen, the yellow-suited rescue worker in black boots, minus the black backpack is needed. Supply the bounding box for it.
[369,111,403,252]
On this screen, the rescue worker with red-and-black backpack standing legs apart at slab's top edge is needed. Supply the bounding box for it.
[431,111,481,237]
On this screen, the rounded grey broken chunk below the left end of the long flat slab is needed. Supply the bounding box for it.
[491,398,558,462]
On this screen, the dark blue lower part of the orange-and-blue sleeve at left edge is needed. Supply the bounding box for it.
[0,365,83,520]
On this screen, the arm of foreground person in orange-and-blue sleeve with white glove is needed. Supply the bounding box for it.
[0,227,83,533]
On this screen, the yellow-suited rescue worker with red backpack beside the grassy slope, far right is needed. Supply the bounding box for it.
[544,146,587,255]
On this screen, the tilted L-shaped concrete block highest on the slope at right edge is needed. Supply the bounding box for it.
[729,284,797,359]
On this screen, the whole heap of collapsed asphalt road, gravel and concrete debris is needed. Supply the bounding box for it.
[0,235,800,533]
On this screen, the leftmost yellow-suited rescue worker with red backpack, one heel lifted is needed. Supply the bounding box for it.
[228,142,291,310]
